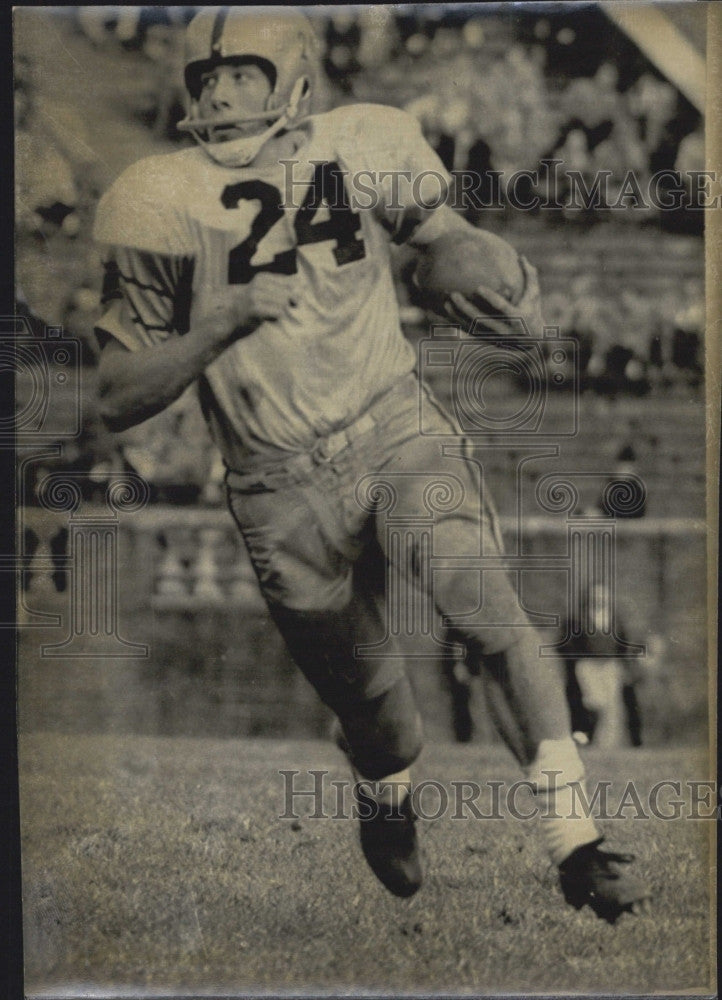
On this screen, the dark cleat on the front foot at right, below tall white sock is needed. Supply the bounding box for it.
[559,837,651,924]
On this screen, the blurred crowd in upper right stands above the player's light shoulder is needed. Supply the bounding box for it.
[325,6,704,226]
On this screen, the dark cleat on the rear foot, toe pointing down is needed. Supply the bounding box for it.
[355,785,423,897]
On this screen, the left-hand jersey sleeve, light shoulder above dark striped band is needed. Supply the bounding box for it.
[94,160,194,350]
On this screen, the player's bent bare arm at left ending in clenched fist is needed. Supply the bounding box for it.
[96,274,293,431]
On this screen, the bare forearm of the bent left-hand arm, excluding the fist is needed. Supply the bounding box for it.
[98,331,227,431]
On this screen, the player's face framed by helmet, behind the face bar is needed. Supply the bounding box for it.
[198,63,271,142]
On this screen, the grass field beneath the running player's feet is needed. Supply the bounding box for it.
[20,734,712,997]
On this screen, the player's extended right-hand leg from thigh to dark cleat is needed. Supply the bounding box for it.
[379,414,648,916]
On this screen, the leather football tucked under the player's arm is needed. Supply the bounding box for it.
[414,229,524,315]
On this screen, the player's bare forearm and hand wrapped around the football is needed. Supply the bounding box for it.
[408,205,544,336]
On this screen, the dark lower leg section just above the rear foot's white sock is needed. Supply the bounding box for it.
[339,677,422,781]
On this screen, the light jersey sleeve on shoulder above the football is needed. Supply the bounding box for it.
[336,104,451,243]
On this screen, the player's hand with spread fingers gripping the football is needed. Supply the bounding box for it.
[446,255,544,338]
